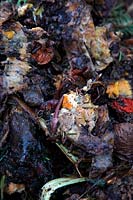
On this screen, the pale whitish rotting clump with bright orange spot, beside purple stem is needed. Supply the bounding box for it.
[59,92,98,138]
